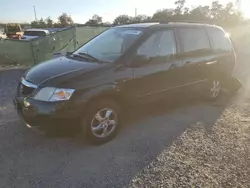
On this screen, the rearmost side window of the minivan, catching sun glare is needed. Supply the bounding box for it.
[207,28,232,51]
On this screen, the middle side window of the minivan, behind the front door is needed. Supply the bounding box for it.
[179,28,210,52]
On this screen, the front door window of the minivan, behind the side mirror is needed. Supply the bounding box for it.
[137,30,176,58]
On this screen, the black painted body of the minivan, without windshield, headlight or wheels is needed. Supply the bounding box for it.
[14,23,235,136]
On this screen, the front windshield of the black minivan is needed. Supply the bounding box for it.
[74,28,141,62]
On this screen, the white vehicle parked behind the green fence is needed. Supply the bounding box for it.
[21,29,51,40]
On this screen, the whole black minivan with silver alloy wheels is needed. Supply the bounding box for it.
[14,22,236,143]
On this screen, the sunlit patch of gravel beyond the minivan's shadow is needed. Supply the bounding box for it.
[129,95,250,188]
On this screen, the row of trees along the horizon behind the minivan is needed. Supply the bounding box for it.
[31,0,244,28]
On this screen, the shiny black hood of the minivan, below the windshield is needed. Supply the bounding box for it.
[25,57,103,85]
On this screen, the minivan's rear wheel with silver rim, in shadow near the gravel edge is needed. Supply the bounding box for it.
[205,79,222,101]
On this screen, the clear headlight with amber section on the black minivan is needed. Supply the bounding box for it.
[34,87,75,102]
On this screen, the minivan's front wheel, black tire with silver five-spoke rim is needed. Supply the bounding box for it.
[81,99,121,144]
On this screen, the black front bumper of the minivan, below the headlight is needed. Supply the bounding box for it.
[13,97,80,132]
